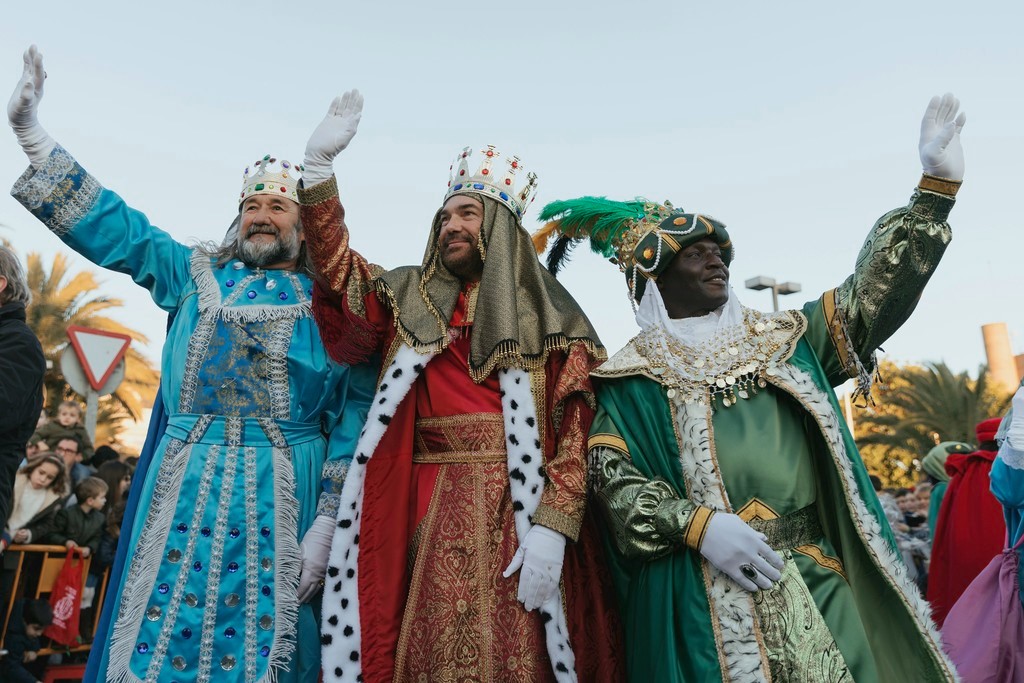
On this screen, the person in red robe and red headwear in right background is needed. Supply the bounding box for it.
[928,418,1007,628]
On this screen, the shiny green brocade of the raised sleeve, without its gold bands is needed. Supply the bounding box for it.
[837,189,953,358]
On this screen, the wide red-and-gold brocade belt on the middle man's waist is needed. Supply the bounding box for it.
[413,413,507,464]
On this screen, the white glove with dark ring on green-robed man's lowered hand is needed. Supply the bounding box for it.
[700,512,783,593]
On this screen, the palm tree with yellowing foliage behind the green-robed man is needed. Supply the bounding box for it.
[854,360,1013,486]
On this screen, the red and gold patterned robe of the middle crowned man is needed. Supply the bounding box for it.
[302,184,624,681]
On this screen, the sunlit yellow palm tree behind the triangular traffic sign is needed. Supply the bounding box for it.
[26,253,160,444]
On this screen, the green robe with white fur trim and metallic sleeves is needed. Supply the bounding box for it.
[590,187,954,682]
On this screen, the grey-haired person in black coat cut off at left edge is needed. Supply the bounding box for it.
[0,246,46,552]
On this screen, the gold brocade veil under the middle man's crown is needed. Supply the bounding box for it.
[377,197,607,382]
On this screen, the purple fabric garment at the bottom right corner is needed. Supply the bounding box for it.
[942,537,1024,683]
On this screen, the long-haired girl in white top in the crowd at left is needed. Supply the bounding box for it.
[0,454,68,552]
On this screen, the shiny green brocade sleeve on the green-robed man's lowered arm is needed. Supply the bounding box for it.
[589,446,696,560]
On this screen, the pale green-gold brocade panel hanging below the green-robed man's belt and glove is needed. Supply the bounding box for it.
[753,551,853,683]
